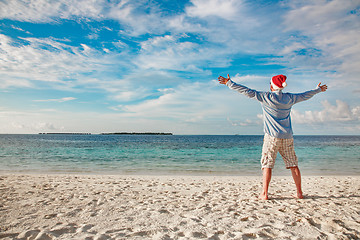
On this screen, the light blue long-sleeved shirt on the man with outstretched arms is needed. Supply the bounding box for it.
[226,80,321,138]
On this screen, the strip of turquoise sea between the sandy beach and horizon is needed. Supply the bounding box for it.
[0,135,360,175]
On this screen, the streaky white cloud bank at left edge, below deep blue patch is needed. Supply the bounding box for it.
[0,34,122,90]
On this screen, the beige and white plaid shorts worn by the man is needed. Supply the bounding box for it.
[261,134,298,168]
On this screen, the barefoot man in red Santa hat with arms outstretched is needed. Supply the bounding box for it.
[218,74,327,200]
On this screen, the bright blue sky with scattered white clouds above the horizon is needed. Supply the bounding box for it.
[0,0,360,135]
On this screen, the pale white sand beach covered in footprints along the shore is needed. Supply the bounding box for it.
[0,174,360,239]
